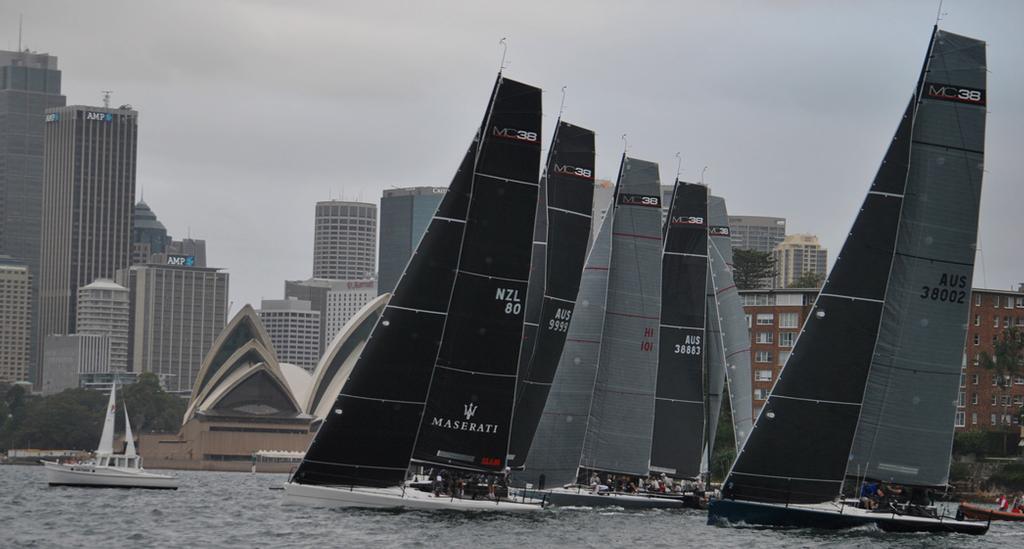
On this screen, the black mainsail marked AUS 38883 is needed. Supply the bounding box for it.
[650,180,708,478]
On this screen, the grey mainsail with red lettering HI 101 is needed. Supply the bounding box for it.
[573,157,663,475]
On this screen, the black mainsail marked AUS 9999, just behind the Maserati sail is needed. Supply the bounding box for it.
[509,120,594,468]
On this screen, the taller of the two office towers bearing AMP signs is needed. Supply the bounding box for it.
[36,105,138,382]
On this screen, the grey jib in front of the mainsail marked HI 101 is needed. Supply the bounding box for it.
[516,193,614,488]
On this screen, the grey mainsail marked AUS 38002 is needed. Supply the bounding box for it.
[847,31,986,487]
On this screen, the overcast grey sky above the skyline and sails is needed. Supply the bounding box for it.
[0,0,1024,311]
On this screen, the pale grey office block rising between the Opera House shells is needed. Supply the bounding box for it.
[256,299,321,372]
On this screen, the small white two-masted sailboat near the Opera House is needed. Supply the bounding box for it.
[42,385,178,490]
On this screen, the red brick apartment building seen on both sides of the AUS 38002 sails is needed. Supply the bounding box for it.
[739,287,1024,432]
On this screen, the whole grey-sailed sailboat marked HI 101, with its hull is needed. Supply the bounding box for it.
[517,155,682,507]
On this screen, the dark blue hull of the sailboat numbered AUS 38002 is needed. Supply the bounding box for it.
[708,500,988,535]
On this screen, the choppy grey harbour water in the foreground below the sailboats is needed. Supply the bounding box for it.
[0,466,1024,549]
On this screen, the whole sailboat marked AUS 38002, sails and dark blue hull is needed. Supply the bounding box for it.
[709,28,988,534]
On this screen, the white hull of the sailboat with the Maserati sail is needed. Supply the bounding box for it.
[285,482,542,513]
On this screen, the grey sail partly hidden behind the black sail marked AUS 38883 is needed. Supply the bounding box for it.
[708,196,754,449]
